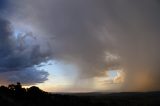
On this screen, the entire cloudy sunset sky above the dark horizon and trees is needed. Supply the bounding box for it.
[0,0,160,92]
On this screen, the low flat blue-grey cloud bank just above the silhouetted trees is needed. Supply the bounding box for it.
[0,67,49,85]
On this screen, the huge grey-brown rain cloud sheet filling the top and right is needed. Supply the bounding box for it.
[8,0,160,90]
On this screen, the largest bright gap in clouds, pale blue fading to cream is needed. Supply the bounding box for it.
[36,60,77,92]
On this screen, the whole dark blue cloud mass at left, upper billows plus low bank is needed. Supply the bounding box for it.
[0,17,49,84]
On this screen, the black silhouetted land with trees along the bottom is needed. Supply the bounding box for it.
[0,83,160,106]
